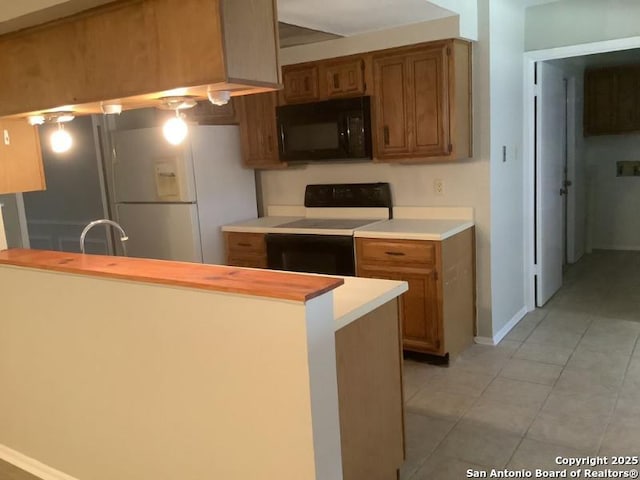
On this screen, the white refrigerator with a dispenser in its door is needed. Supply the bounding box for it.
[113,125,257,264]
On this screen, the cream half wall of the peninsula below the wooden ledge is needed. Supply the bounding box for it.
[0,265,342,480]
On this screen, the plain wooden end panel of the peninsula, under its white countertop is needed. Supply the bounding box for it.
[335,299,404,480]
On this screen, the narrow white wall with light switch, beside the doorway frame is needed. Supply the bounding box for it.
[488,0,529,335]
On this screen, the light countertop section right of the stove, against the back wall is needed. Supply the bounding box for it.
[354,218,474,240]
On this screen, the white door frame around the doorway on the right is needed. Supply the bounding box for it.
[522,36,640,311]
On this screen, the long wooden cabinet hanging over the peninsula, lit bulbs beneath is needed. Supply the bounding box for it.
[0,0,280,117]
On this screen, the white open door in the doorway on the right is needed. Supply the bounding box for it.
[536,62,565,307]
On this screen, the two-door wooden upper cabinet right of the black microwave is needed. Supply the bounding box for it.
[373,40,472,162]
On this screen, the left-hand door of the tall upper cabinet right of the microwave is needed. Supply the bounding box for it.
[373,55,411,159]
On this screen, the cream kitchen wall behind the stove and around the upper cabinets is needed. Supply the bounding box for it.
[260,17,493,336]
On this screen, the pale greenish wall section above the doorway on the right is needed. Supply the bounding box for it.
[525,0,640,51]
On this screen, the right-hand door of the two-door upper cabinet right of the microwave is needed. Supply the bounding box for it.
[407,46,452,157]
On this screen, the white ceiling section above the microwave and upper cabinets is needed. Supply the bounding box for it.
[278,0,456,36]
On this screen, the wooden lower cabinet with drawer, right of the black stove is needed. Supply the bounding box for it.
[356,229,475,357]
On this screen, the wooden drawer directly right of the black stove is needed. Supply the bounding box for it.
[356,238,436,265]
